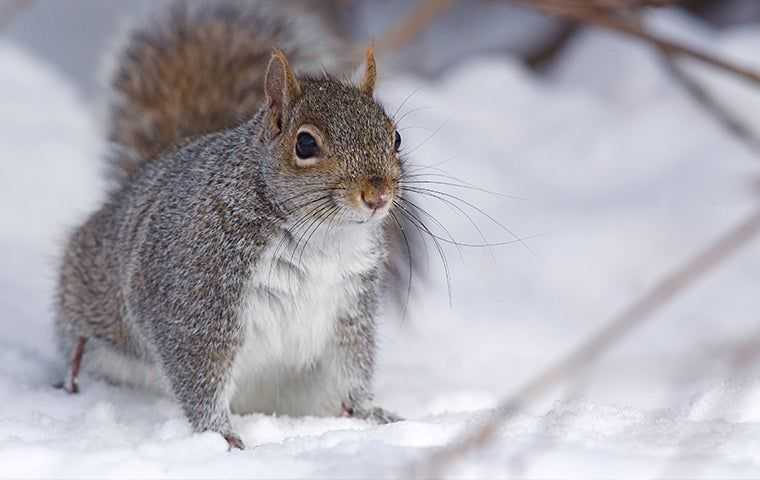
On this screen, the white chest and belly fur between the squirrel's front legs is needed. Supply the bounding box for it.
[227,226,378,414]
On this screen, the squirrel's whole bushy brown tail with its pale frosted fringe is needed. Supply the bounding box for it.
[109,0,348,183]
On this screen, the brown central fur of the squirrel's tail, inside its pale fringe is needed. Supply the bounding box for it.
[111,6,274,176]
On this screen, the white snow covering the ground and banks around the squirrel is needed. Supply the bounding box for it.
[0,9,760,478]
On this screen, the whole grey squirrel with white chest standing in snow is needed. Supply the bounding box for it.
[55,0,404,449]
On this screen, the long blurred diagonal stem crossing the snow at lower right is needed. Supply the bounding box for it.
[410,209,760,478]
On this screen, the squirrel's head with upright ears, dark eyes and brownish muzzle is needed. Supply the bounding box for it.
[262,48,402,228]
